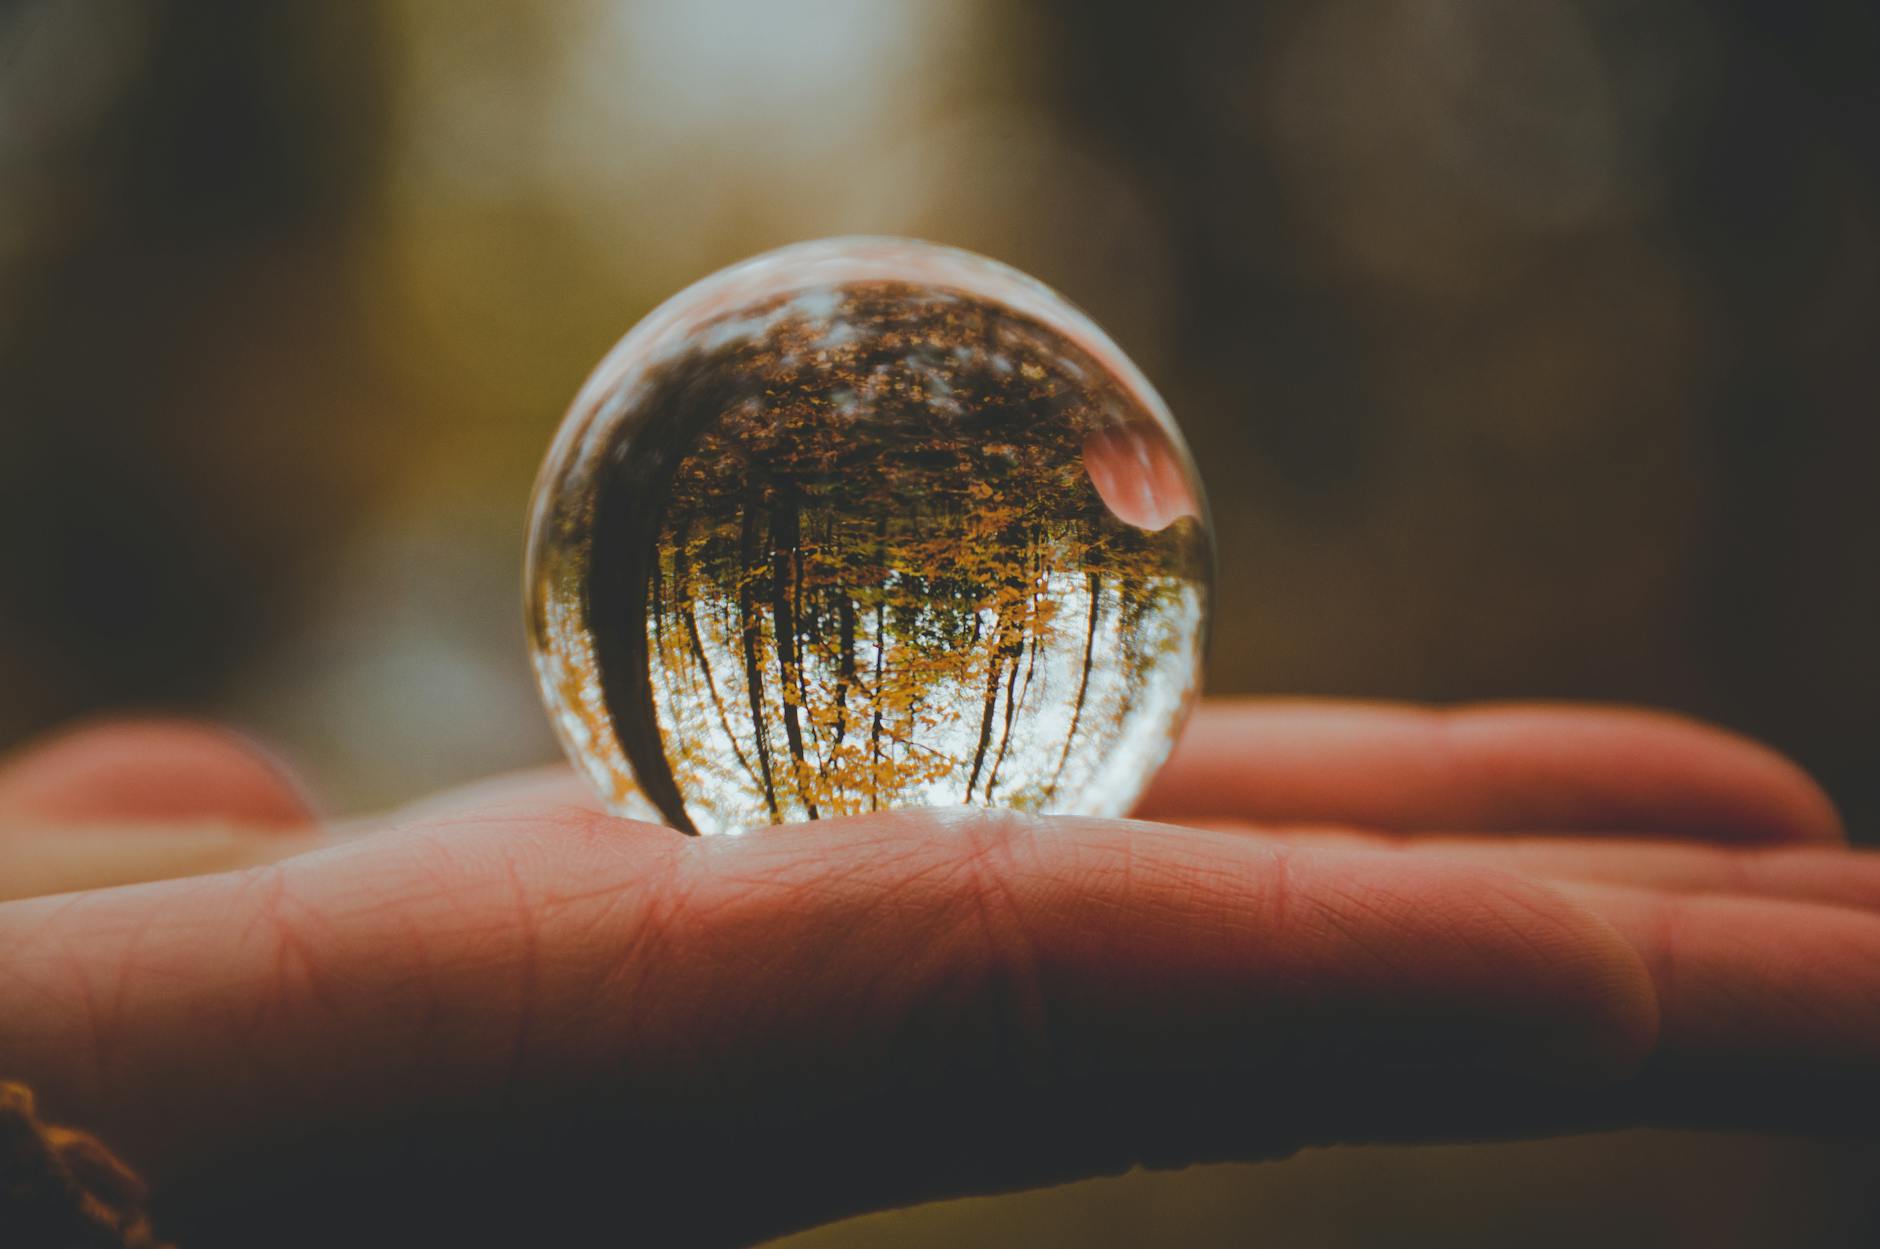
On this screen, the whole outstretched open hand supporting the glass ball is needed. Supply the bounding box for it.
[0,704,1880,1249]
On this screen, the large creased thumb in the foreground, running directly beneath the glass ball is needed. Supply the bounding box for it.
[0,811,1653,1230]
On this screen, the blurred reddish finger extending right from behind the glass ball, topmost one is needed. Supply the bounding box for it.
[1141,702,1844,843]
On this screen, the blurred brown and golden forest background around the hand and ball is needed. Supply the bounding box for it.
[0,0,1880,1249]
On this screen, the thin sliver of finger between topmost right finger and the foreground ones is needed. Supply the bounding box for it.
[1180,820,1880,910]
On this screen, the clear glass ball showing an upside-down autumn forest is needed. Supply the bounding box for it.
[528,239,1213,833]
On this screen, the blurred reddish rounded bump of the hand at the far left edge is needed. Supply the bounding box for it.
[0,720,312,831]
